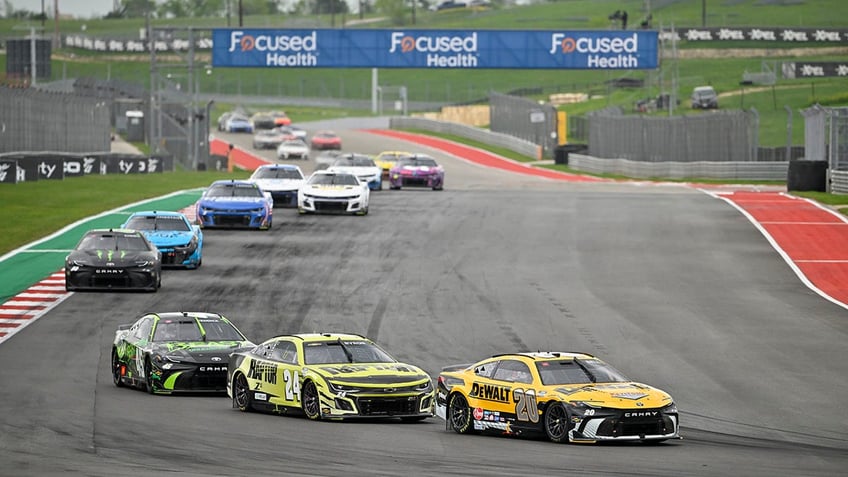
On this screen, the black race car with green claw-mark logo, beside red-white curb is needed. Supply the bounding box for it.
[65,229,162,292]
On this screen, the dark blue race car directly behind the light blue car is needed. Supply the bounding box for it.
[195,179,274,230]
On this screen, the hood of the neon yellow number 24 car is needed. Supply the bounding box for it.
[308,363,430,386]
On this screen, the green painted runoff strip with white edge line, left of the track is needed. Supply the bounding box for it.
[0,189,203,303]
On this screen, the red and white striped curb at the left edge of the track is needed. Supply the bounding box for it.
[0,270,71,343]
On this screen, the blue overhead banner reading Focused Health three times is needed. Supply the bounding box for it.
[212,28,659,70]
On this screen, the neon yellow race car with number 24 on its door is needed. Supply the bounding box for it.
[227,333,435,421]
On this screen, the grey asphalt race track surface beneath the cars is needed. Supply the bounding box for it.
[0,123,848,476]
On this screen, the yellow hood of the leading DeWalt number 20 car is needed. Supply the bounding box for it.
[546,382,672,409]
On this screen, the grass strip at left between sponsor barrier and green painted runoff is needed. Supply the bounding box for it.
[0,171,250,255]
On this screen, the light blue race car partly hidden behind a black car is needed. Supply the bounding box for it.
[121,210,203,268]
